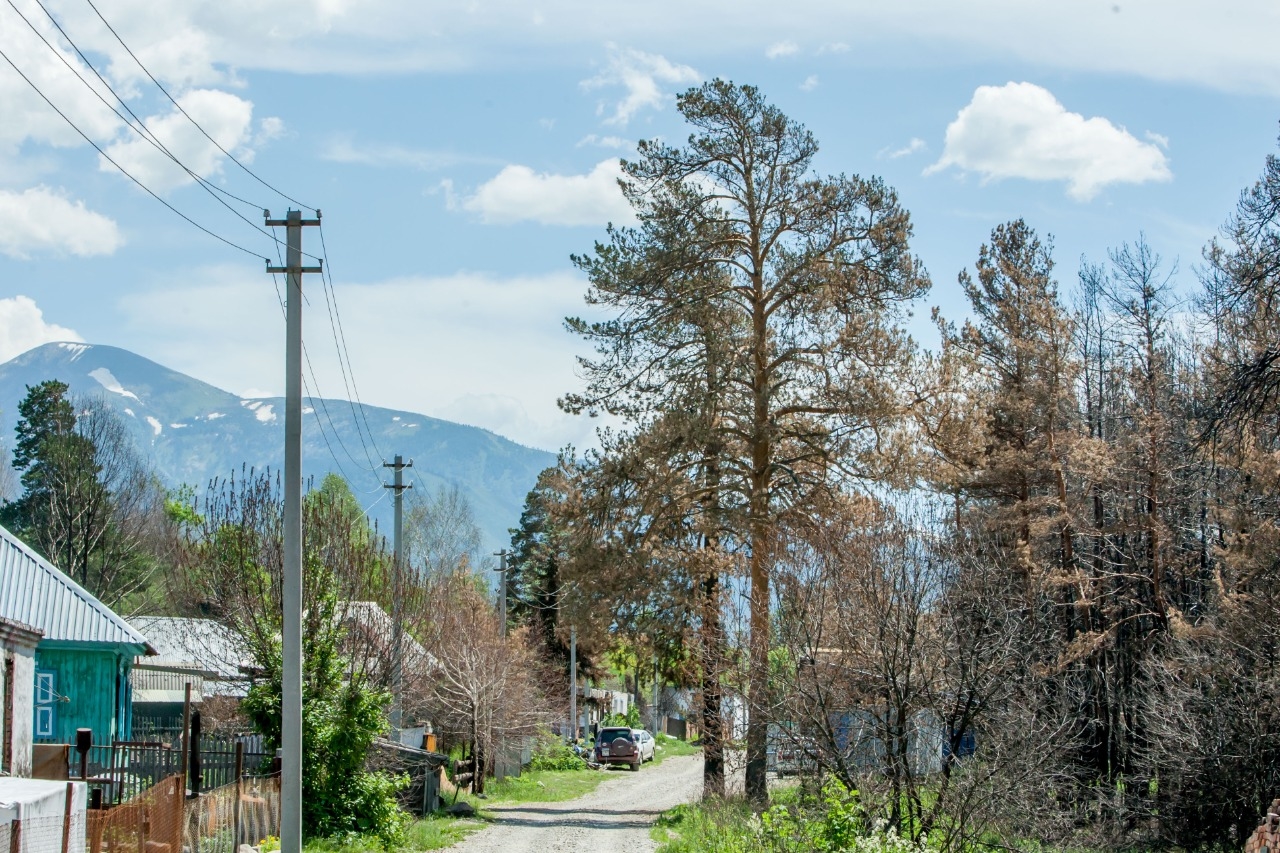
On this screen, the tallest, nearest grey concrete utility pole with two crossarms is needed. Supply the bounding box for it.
[262,210,324,853]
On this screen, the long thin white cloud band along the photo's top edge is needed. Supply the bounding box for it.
[0,0,1280,95]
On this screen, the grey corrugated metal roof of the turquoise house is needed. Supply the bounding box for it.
[0,517,155,654]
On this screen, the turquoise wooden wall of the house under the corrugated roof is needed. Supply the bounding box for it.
[36,643,142,744]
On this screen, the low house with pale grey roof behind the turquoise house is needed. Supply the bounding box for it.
[129,616,251,738]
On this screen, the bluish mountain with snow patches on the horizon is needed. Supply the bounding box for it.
[0,343,556,549]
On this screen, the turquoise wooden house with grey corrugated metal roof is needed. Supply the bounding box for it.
[0,526,155,743]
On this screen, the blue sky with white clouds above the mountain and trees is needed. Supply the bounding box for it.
[0,0,1280,452]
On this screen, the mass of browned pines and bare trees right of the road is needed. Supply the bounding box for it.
[496,81,1280,849]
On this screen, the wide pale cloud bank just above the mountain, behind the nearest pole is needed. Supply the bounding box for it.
[120,265,600,450]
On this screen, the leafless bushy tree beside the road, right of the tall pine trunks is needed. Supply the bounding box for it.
[772,498,1062,848]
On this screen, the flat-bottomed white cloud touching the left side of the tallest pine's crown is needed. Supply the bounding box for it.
[462,160,634,227]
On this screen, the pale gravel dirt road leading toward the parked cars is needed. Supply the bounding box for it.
[449,756,703,853]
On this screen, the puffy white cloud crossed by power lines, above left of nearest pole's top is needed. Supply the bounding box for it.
[99,88,253,193]
